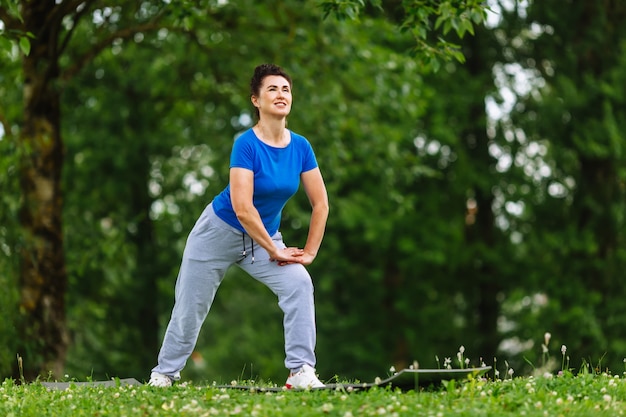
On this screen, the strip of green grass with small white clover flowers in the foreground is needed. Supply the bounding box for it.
[0,373,626,417]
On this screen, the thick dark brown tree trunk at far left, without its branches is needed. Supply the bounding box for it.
[15,1,68,380]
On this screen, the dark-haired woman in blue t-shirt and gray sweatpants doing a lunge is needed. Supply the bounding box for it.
[149,64,328,388]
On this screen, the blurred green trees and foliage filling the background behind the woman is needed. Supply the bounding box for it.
[0,0,626,383]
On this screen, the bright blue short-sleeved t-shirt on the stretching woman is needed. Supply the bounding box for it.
[213,129,317,236]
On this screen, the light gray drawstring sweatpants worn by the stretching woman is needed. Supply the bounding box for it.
[152,204,316,380]
